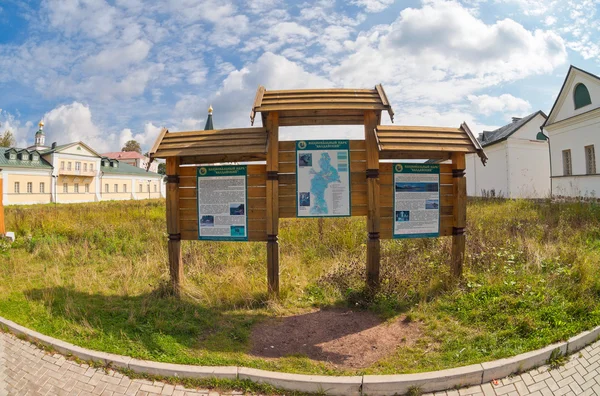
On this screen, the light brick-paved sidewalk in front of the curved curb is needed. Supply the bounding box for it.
[0,333,600,396]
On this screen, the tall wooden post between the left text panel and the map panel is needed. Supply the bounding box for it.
[267,112,279,296]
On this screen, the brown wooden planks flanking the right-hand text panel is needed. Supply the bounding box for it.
[379,162,454,239]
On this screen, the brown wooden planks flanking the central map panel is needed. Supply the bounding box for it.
[279,140,367,218]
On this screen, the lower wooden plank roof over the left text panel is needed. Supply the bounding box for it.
[150,128,267,164]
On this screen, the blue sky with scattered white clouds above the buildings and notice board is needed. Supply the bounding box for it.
[0,0,600,151]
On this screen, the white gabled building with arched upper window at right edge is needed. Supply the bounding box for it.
[544,66,600,198]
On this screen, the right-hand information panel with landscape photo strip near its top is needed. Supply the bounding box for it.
[393,163,440,238]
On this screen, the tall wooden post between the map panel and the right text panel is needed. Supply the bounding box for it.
[365,111,380,288]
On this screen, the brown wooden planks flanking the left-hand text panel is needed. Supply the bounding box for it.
[179,165,267,241]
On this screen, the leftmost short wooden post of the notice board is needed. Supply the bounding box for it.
[167,157,183,296]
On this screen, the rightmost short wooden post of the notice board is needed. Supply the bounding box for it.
[452,153,467,279]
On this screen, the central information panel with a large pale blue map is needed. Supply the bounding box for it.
[296,140,350,217]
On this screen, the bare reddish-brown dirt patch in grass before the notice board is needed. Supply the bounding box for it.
[250,310,421,368]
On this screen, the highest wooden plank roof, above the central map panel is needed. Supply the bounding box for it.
[250,84,394,126]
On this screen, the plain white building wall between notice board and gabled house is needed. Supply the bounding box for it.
[466,111,550,199]
